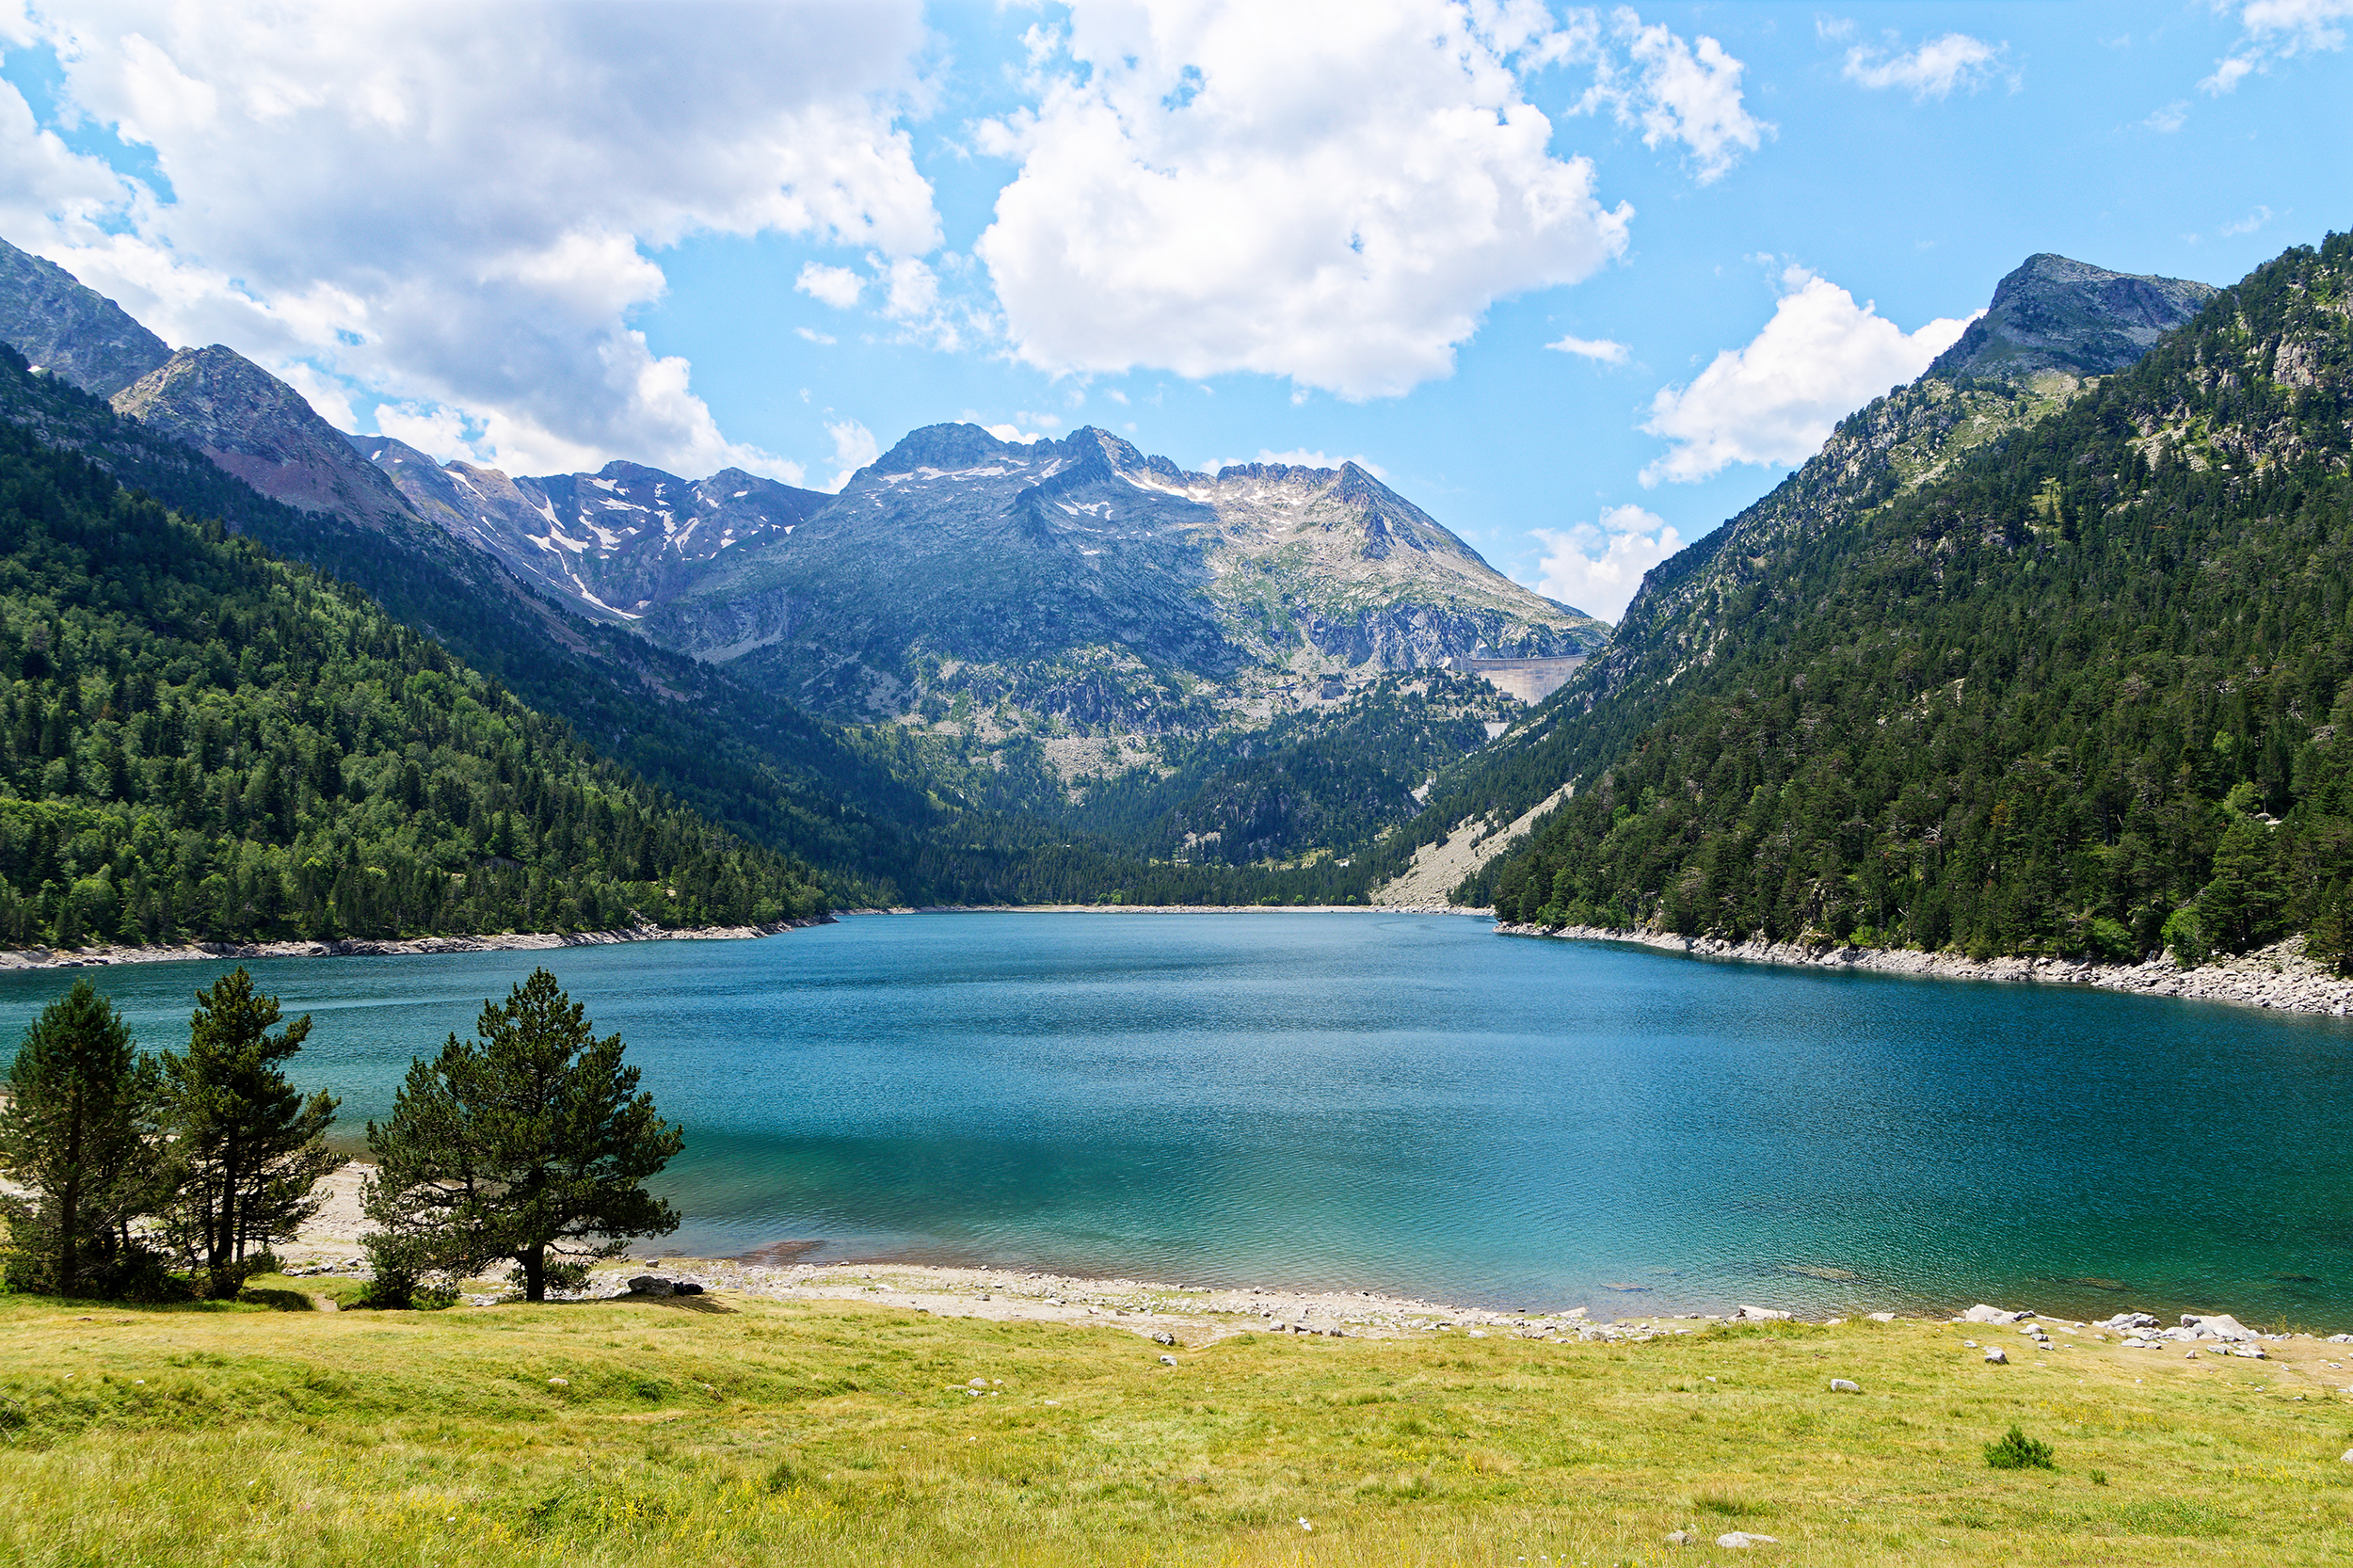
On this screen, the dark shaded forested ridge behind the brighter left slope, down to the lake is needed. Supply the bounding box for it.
[0,346,1412,899]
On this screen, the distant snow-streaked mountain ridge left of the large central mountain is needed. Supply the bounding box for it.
[351,436,833,621]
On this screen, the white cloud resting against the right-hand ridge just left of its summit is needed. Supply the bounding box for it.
[1642,266,1977,485]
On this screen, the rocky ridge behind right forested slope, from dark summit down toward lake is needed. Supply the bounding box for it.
[1379,254,2215,902]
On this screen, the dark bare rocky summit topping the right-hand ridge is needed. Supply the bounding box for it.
[1929,252,2217,379]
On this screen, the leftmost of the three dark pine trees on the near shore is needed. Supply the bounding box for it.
[0,980,158,1295]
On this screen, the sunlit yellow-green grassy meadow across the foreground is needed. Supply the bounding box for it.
[0,1281,2353,1568]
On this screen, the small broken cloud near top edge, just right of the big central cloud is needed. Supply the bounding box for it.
[1570,8,1774,186]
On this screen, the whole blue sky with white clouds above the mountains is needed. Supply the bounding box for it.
[0,0,2353,615]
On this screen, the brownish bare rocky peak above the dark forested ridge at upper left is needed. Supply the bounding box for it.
[111,344,414,530]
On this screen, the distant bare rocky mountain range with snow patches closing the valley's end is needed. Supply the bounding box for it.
[353,424,1608,732]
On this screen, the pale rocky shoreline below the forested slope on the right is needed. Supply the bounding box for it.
[1497,923,2353,1017]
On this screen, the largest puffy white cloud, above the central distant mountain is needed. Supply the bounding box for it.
[977,0,1633,400]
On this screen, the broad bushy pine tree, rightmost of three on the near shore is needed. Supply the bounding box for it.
[365,970,685,1302]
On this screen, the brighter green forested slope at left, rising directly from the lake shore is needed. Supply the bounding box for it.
[0,400,822,947]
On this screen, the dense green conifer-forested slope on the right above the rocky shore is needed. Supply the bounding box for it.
[1464,235,2353,961]
